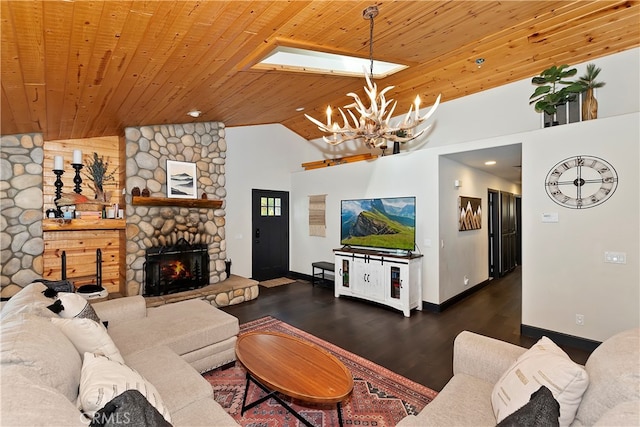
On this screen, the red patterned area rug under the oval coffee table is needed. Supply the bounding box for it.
[204,316,437,427]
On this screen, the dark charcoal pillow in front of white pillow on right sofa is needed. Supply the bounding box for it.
[497,386,560,427]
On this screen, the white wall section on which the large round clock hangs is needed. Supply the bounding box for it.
[522,113,640,341]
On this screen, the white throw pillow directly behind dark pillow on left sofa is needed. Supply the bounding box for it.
[78,353,171,423]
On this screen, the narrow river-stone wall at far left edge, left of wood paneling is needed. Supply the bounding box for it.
[0,134,44,296]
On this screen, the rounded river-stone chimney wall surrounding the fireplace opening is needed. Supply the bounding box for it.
[125,122,227,295]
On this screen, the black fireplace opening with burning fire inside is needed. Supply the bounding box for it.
[143,239,209,296]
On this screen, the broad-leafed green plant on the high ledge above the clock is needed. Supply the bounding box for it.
[529,64,583,126]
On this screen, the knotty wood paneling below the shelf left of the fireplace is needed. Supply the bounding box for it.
[43,230,123,293]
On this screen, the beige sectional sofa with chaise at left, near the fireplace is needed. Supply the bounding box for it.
[0,283,239,426]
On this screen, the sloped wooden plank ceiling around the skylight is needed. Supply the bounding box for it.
[0,0,640,140]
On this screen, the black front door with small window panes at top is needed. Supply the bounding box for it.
[251,189,289,281]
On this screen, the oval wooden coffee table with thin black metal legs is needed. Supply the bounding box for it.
[236,332,353,427]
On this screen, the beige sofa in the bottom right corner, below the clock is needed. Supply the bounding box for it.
[398,329,640,427]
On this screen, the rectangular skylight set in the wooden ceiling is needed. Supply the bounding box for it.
[252,46,407,79]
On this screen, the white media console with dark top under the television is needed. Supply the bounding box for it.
[334,248,422,317]
